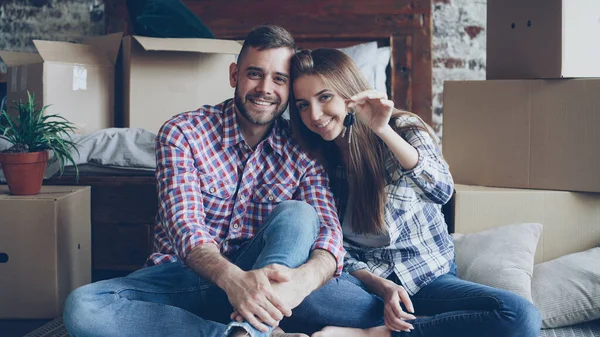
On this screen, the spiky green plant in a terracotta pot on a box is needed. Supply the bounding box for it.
[0,92,79,195]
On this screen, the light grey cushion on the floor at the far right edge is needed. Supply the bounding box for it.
[531,247,600,328]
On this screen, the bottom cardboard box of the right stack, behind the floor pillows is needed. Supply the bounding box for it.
[444,184,600,263]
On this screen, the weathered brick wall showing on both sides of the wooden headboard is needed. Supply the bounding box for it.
[0,0,487,135]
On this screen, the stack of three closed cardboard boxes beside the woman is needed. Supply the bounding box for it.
[443,0,600,262]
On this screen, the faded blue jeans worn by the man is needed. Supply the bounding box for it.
[64,201,319,337]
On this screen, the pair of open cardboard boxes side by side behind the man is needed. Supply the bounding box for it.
[0,33,242,134]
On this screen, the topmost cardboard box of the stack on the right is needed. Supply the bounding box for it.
[486,0,600,80]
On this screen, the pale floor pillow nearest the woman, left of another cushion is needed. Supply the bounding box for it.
[453,223,542,302]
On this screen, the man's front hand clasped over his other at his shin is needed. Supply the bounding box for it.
[223,265,292,332]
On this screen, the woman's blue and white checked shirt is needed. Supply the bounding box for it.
[332,116,454,295]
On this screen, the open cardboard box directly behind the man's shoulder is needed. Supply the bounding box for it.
[122,36,242,132]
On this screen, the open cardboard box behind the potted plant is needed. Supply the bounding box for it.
[0,33,122,134]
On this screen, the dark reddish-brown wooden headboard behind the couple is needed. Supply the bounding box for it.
[106,0,432,125]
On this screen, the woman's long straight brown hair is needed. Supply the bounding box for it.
[290,48,435,234]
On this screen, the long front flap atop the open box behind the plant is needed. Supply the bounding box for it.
[33,40,113,66]
